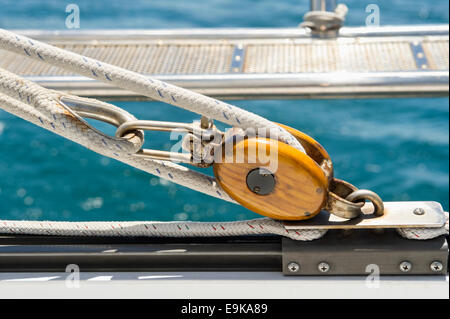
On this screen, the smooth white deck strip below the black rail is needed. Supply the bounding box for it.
[0,272,449,299]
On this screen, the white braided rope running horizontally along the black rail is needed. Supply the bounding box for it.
[0,218,327,241]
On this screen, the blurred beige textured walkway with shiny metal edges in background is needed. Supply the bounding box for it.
[0,25,449,100]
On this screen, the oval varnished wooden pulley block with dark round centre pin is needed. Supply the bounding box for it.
[213,125,333,220]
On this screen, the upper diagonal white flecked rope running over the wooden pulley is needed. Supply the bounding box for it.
[0,29,305,152]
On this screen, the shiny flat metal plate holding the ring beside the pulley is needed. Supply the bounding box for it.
[283,202,446,230]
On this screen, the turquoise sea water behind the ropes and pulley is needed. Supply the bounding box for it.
[0,0,449,221]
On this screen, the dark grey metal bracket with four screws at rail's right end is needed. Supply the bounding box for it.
[282,229,448,276]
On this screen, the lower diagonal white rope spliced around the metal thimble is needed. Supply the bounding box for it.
[0,69,234,202]
